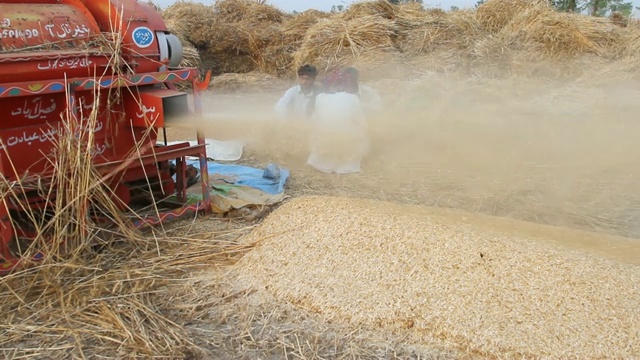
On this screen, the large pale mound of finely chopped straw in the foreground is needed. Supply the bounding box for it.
[236,197,640,359]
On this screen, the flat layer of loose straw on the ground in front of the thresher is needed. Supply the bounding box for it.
[0,229,245,359]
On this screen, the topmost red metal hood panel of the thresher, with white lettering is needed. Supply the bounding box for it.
[0,0,109,83]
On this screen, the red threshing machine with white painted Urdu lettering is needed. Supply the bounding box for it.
[0,0,215,272]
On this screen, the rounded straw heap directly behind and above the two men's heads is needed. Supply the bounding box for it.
[294,15,396,71]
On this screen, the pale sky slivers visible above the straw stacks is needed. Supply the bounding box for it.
[154,0,640,13]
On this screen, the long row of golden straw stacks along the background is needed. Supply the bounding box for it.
[159,0,640,77]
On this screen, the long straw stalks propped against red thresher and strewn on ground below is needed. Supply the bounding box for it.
[0,36,234,359]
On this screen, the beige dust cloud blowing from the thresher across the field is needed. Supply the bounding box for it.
[166,67,640,242]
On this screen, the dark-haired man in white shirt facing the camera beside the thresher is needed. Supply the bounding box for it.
[274,65,320,120]
